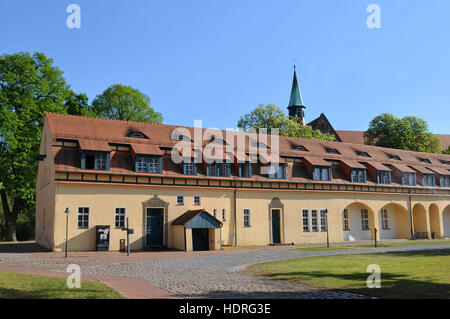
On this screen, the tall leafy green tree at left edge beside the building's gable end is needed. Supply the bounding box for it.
[0,52,70,240]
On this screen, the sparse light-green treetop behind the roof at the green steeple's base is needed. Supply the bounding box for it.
[238,104,335,141]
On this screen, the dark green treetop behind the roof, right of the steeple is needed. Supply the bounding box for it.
[364,113,442,153]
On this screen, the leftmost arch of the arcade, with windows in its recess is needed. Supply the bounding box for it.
[342,203,374,241]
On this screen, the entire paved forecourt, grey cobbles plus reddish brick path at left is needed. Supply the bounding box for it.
[0,244,450,299]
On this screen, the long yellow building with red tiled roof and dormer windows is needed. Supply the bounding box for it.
[36,113,450,251]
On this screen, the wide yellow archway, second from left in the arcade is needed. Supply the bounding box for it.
[379,203,411,239]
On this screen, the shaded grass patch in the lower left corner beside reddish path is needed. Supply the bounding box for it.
[0,272,122,299]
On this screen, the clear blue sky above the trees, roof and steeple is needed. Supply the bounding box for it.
[0,0,450,134]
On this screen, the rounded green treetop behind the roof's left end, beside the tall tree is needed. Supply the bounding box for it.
[92,84,163,123]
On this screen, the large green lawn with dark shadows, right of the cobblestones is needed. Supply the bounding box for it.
[249,249,450,298]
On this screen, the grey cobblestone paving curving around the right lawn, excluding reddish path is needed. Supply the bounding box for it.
[72,245,450,298]
